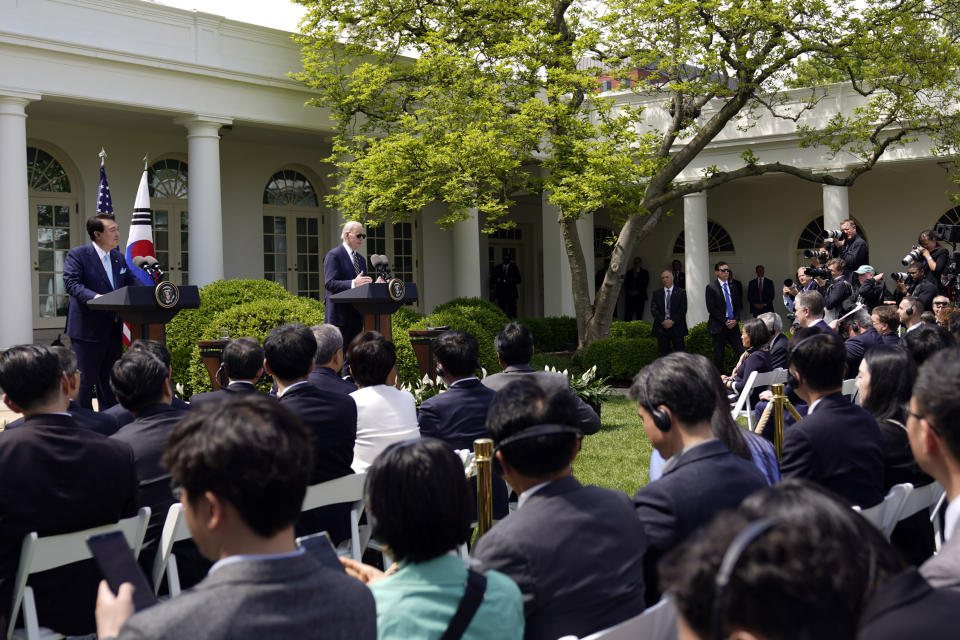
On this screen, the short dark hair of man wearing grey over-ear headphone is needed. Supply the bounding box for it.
[629,352,720,425]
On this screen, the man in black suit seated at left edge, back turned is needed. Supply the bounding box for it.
[0,345,137,635]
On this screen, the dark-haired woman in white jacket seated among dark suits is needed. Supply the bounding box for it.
[347,331,420,473]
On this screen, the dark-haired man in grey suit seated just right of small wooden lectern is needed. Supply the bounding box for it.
[481,322,600,435]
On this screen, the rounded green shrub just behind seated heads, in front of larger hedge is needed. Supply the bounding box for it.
[183,296,323,398]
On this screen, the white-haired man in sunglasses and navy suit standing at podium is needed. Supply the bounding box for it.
[323,220,373,347]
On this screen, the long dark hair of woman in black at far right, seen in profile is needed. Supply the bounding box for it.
[860,344,917,422]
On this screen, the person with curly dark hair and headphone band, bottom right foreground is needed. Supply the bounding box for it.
[661,480,960,640]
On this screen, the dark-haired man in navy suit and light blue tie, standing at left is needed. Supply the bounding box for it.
[63,214,140,411]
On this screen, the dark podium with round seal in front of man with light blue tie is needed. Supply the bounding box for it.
[87,285,200,344]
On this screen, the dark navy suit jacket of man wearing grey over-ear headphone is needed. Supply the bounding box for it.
[633,439,767,606]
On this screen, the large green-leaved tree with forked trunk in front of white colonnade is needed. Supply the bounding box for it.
[295,0,958,348]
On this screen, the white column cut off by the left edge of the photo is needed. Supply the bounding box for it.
[0,90,40,349]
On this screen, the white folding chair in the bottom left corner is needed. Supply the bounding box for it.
[6,507,150,640]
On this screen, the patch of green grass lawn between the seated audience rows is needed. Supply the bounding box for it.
[573,396,653,497]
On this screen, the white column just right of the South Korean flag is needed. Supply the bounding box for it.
[177,115,233,286]
